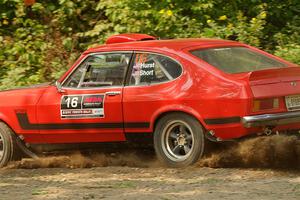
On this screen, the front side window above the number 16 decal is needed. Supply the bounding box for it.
[63,53,131,88]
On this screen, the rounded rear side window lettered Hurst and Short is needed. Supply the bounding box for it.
[129,53,182,85]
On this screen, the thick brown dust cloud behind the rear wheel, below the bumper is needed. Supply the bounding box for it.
[196,135,300,169]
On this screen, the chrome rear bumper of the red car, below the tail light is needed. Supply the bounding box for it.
[242,111,300,128]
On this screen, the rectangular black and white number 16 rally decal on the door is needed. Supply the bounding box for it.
[60,94,105,119]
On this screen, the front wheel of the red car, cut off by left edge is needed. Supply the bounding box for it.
[0,122,19,168]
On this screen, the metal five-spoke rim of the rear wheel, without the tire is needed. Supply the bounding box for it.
[162,120,194,162]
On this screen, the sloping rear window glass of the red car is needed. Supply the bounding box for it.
[191,47,287,74]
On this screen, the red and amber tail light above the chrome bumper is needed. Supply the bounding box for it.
[252,98,279,112]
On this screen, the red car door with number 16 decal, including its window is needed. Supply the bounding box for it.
[37,52,132,143]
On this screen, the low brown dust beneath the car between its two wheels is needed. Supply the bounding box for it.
[6,152,159,169]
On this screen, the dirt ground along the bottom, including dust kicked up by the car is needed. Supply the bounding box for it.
[0,136,300,200]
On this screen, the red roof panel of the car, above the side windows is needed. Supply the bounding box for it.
[85,38,242,53]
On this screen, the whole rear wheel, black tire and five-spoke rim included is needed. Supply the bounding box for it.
[154,113,205,167]
